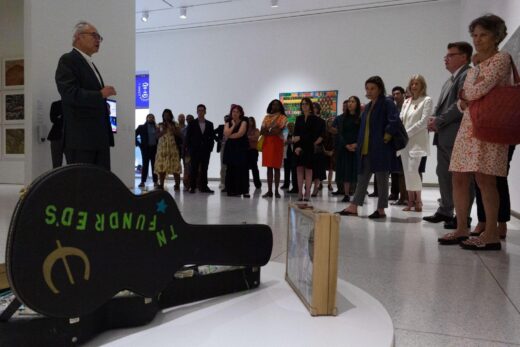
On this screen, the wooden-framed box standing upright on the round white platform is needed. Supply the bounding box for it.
[285,203,340,316]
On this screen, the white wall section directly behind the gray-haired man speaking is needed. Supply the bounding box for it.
[25,0,135,186]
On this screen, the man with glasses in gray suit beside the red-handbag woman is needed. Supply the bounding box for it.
[423,42,473,223]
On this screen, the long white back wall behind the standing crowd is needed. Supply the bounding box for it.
[136,1,460,182]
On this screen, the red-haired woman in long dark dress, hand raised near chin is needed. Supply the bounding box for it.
[223,105,249,198]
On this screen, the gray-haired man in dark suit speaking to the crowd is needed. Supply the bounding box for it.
[55,22,116,170]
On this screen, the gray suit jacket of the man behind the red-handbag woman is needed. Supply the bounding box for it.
[433,65,469,147]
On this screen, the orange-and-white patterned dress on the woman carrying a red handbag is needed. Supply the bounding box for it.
[450,52,512,177]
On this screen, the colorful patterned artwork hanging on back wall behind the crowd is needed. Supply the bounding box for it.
[280,90,338,122]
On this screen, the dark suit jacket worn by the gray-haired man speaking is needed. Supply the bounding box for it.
[55,49,114,150]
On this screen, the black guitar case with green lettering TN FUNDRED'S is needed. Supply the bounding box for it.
[0,165,273,346]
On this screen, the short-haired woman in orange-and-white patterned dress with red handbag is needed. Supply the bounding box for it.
[439,15,511,250]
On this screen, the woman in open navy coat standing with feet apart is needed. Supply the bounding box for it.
[338,76,400,219]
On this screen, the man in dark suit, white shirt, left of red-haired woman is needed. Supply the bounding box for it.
[185,104,215,193]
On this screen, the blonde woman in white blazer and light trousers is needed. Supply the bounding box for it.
[397,75,433,212]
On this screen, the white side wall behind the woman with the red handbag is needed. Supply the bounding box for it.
[460,0,520,214]
